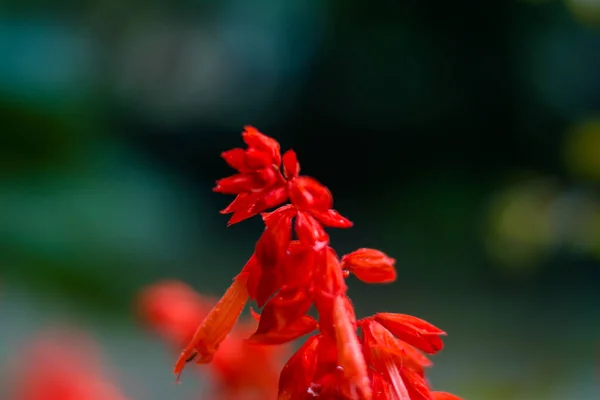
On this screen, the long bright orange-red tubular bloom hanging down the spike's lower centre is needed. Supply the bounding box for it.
[333,296,373,400]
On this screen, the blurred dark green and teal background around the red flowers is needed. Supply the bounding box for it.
[0,0,600,400]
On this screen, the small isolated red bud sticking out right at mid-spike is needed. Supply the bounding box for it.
[342,248,396,283]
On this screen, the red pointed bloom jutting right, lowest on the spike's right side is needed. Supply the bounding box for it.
[374,313,446,354]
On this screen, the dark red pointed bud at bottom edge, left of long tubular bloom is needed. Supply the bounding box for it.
[278,335,321,400]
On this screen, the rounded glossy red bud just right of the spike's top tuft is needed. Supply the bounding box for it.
[289,176,333,211]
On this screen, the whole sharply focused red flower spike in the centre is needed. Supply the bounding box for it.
[174,127,458,400]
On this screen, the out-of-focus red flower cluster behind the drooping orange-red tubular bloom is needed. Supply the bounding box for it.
[137,281,289,400]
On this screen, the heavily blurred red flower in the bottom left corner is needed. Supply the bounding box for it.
[9,330,126,400]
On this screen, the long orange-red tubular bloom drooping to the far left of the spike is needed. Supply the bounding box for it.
[174,275,248,379]
